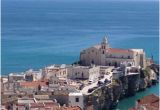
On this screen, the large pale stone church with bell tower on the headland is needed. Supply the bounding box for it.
[80,37,146,68]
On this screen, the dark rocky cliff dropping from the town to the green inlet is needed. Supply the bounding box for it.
[85,64,159,110]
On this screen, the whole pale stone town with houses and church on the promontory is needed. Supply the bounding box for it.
[1,37,152,110]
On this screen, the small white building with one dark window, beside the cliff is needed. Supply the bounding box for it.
[69,93,84,110]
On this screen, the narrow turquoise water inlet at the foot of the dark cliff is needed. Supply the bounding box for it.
[3,64,159,110]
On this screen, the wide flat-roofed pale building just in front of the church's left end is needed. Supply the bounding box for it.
[67,66,100,81]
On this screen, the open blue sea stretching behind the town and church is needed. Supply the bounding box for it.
[1,0,159,110]
